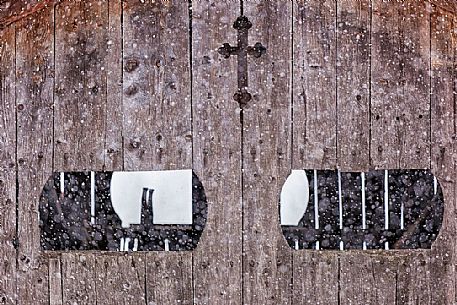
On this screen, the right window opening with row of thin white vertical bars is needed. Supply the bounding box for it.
[280,170,444,250]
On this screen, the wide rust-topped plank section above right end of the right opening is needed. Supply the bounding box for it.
[370,0,430,168]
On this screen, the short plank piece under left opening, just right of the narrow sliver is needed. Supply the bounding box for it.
[61,252,96,305]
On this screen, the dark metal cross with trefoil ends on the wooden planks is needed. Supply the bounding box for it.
[218,16,267,108]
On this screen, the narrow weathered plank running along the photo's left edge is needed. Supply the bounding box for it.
[0,25,17,304]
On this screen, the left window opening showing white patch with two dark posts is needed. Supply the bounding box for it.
[39,170,207,251]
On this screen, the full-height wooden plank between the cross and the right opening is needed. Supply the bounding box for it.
[242,1,292,304]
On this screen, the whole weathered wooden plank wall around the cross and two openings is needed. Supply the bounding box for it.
[0,0,457,305]
